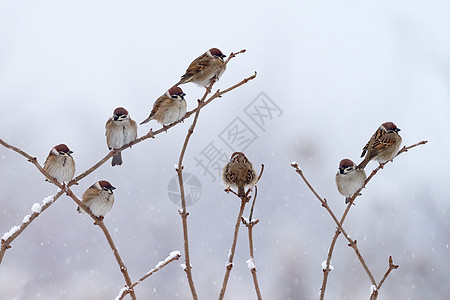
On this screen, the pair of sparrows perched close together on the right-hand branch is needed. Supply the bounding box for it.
[336,122,402,203]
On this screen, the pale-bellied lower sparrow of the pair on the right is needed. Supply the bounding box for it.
[336,159,367,204]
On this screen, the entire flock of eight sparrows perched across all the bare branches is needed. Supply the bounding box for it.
[37,48,402,218]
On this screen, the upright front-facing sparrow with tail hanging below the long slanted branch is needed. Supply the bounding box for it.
[105,107,137,166]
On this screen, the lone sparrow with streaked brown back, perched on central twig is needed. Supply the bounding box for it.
[222,152,258,197]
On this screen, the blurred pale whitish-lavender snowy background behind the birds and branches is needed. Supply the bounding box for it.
[0,1,450,300]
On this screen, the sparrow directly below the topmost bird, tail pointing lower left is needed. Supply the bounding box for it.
[141,86,186,125]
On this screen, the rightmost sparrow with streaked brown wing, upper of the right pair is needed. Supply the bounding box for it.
[358,122,402,169]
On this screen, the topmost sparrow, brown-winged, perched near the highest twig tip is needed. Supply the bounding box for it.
[176,48,226,87]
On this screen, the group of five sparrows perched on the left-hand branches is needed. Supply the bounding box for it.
[44,48,226,218]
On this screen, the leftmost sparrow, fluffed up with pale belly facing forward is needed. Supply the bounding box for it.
[44,144,75,183]
